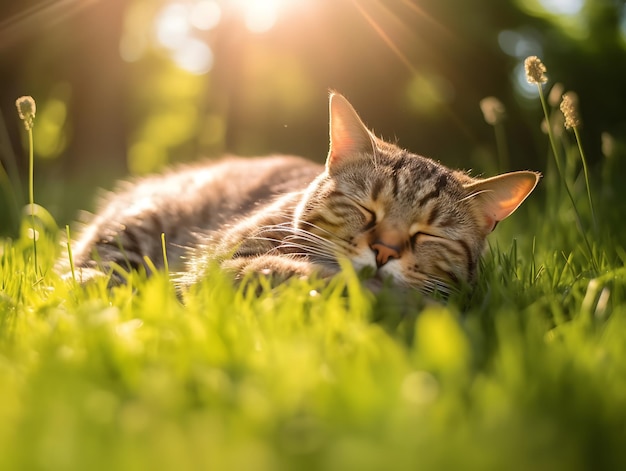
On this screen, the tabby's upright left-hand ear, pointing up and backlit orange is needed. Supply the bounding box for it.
[326,92,375,171]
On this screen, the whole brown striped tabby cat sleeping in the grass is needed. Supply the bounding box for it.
[66,92,540,293]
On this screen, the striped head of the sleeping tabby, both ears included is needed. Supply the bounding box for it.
[296,93,540,291]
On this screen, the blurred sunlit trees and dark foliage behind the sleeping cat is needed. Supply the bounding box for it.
[0,0,626,235]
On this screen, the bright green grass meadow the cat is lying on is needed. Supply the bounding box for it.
[0,63,626,471]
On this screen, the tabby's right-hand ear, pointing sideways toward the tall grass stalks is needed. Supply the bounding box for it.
[465,172,541,233]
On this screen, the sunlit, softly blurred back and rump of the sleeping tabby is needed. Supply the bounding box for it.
[75,155,323,266]
